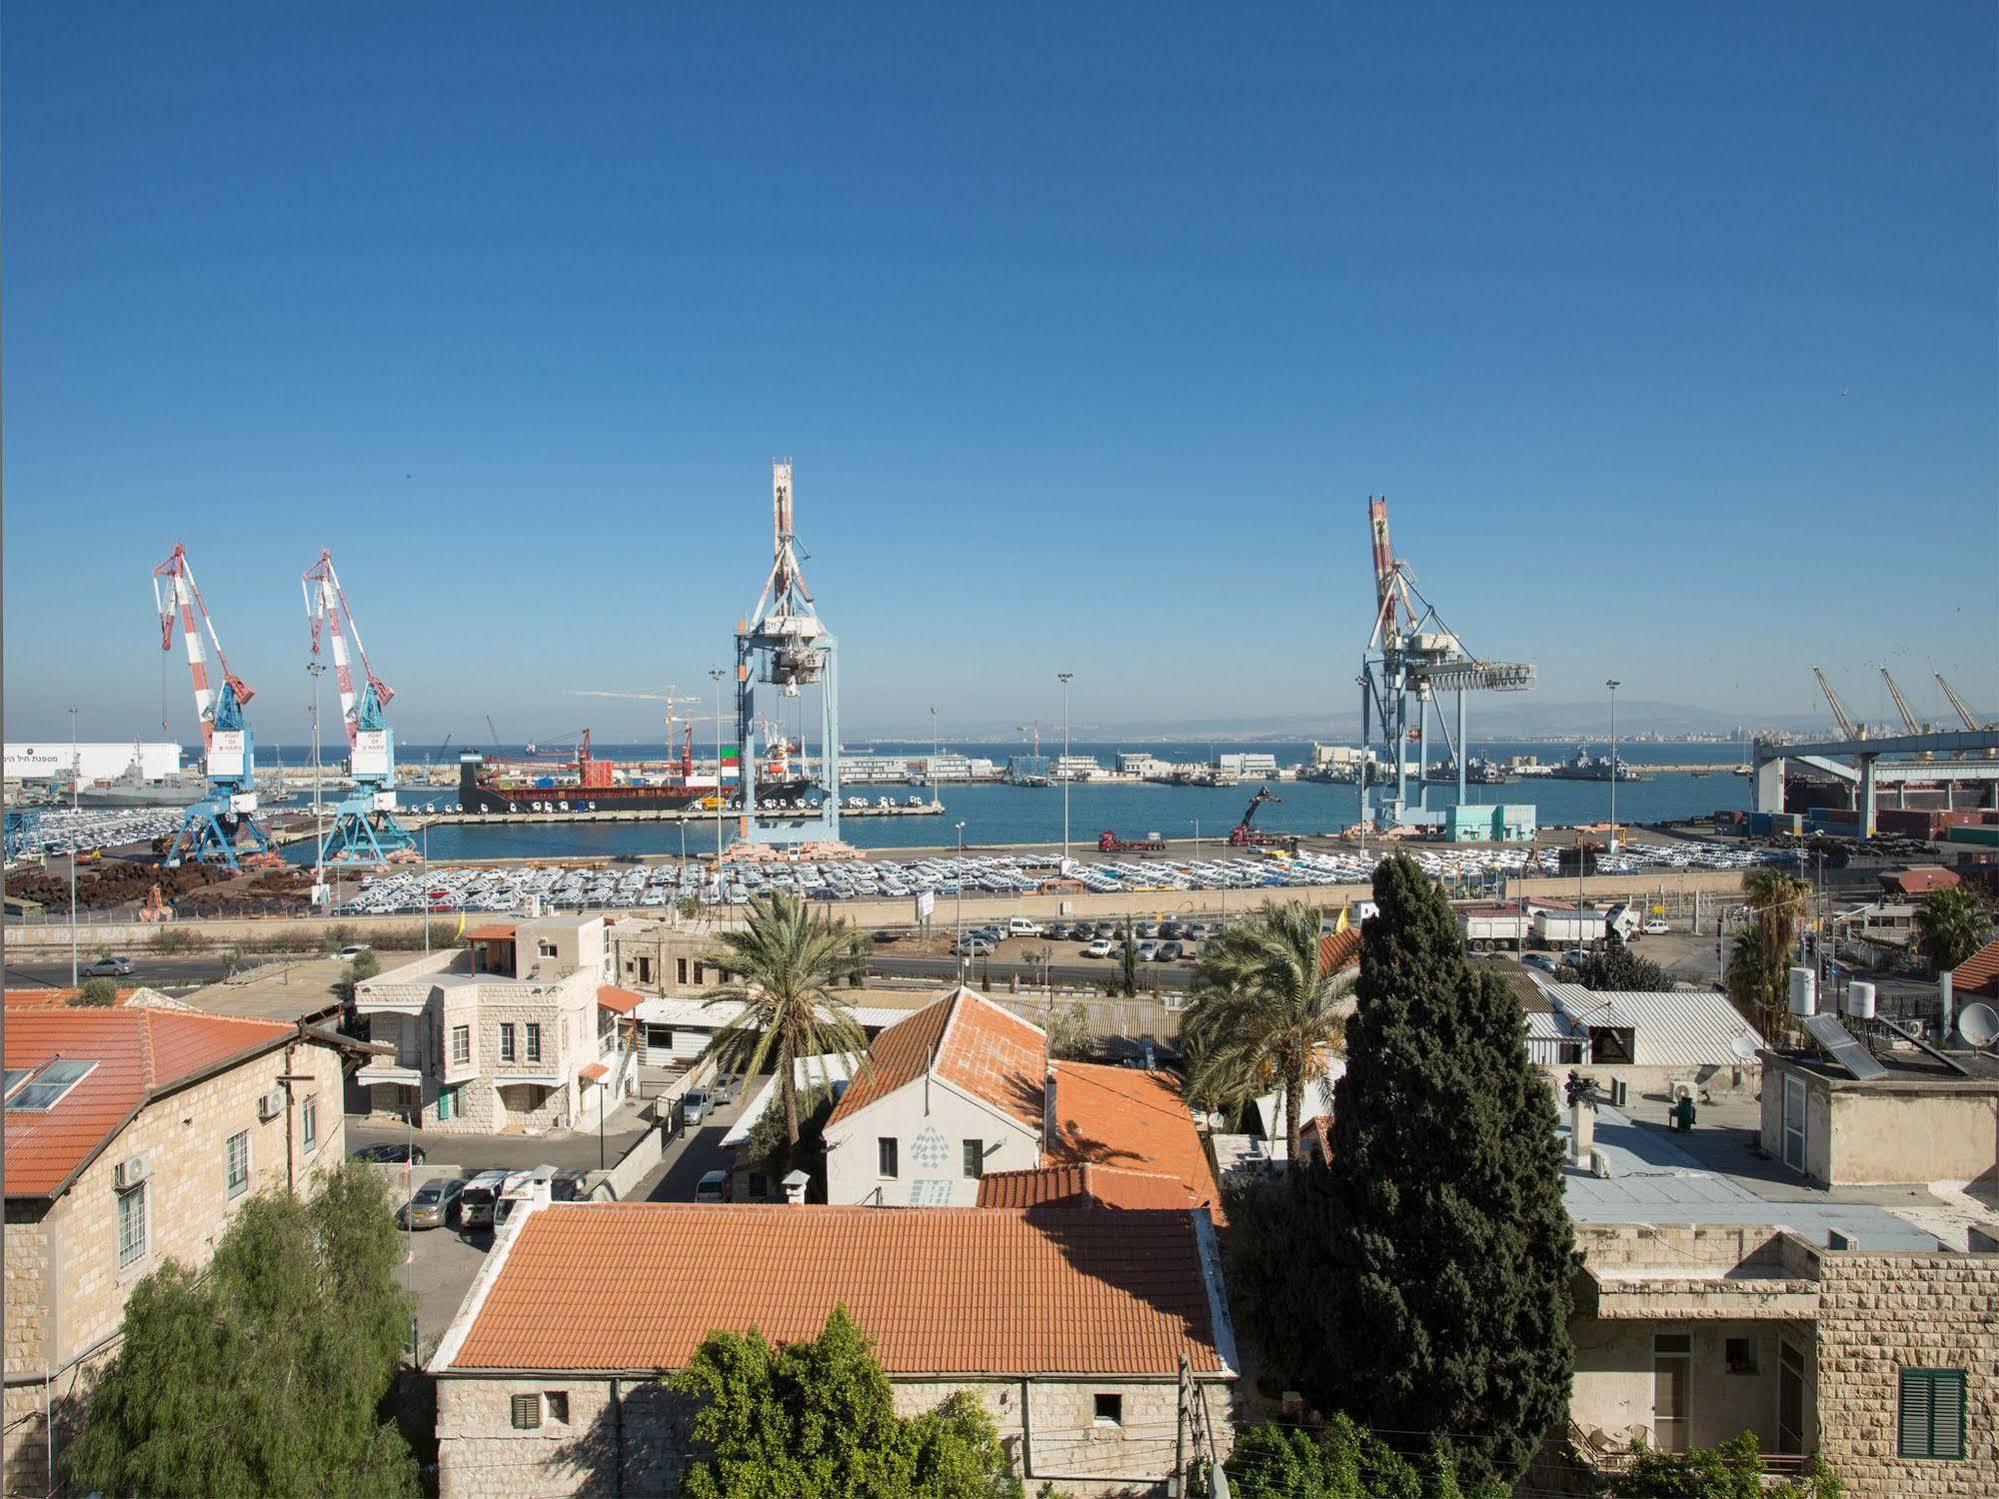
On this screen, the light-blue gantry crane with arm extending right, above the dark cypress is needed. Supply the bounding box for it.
[1357,496,1533,825]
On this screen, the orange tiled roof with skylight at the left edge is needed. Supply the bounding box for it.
[6,1005,298,1197]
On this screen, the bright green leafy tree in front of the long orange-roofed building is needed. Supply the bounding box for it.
[666,1307,1021,1499]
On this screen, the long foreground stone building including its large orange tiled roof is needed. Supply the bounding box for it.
[430,1203,1237,1499]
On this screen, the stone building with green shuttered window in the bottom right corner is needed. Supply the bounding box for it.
[1569,1223,1999,1497]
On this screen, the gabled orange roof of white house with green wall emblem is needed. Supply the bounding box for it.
[828,987,1047,1129]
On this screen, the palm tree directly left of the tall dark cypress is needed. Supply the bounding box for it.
[1181,901,1353,1169]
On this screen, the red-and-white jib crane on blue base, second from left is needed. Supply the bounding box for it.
[300,548,416,867]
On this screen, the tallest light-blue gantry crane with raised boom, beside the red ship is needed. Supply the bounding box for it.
[739,460,840,843]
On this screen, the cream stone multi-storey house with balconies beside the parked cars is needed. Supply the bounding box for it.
[354,915,638,1133]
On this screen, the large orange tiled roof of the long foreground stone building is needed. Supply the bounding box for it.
[444,1203,1225,1375]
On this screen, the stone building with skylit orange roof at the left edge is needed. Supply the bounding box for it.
[4,1007,346,1493]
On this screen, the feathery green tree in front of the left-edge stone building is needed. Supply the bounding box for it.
[68,1163,420,1499]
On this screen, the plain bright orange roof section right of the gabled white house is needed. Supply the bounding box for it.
[1043,1061,1227,1223]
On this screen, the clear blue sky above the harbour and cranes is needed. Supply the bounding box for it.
[0,2,1999,744]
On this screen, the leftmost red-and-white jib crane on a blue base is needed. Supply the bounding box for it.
[152,542,276,869]
